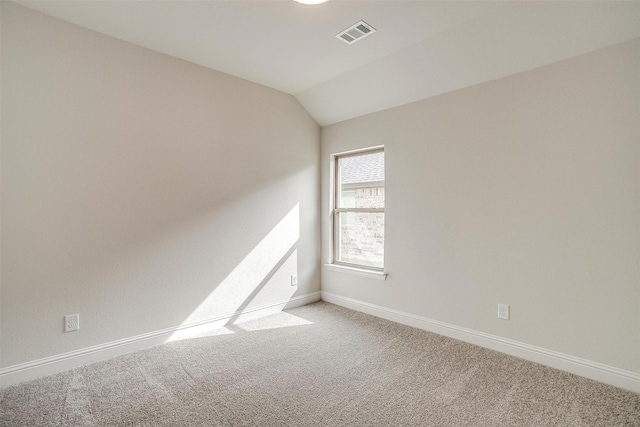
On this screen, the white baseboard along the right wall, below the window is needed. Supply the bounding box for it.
[321,291,640,393]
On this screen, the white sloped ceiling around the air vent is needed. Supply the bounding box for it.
[17,0,640,125]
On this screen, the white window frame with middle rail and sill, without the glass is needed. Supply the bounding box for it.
[326,145,387,280]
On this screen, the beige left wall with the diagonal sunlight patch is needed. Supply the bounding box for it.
[1,2,320,367]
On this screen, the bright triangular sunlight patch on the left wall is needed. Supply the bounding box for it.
[170,204,300,340]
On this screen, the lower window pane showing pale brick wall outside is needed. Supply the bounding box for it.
[336,212,384,268]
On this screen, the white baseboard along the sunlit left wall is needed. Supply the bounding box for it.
[0,292,320,388]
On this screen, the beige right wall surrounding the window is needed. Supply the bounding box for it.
[321,39,640,373]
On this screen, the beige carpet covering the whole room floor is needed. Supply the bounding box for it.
[0,303,640,426]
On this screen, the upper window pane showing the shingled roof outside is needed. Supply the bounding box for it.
[337,151,384,208]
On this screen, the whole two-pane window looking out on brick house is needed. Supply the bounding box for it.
[333,149,385,271]
